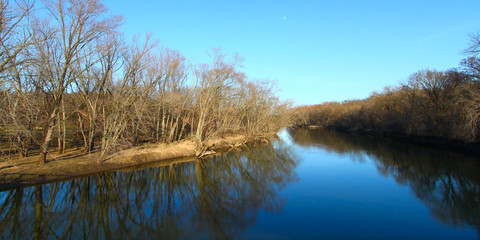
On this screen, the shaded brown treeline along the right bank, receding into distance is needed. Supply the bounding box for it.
[295,32,480,143]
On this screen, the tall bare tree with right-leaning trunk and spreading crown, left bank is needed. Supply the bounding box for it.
[37,0,120,163]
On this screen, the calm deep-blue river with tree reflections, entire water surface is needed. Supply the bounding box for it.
[0,129,480,239]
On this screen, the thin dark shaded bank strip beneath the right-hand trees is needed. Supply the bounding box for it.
[294,125,480,158]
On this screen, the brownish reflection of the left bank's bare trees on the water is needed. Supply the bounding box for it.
[0,142,298,239]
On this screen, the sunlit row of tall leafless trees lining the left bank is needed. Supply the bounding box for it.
[0,0,288,163]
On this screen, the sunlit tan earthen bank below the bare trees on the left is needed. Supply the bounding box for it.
[0,133,276,191]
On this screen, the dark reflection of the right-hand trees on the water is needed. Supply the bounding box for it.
[289,129,480,233]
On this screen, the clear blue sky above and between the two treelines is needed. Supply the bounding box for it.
[104,0,480,105]
